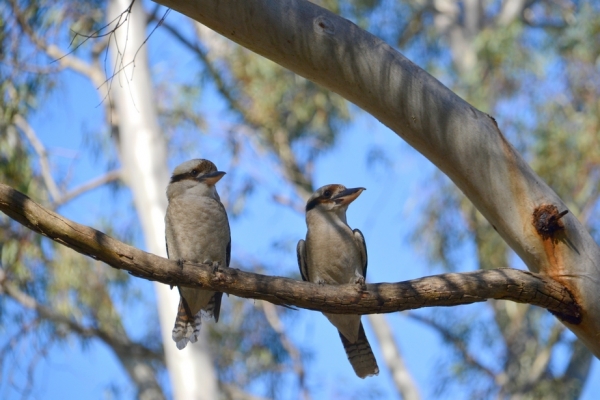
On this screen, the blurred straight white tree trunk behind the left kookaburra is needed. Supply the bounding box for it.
[106,0,218,400]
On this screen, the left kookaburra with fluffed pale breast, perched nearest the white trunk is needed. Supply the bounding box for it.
[165,159,231,350]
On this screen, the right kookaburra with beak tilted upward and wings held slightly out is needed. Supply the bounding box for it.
[296,185,379,378]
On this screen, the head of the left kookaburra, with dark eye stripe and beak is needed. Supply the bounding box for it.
[167,159,225,200]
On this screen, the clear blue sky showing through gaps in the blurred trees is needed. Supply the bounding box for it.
[0,2,600,400]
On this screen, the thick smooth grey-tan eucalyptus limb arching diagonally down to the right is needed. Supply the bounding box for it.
[151,0,600,357]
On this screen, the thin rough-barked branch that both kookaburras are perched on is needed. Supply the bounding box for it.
[0,184,581,324]
